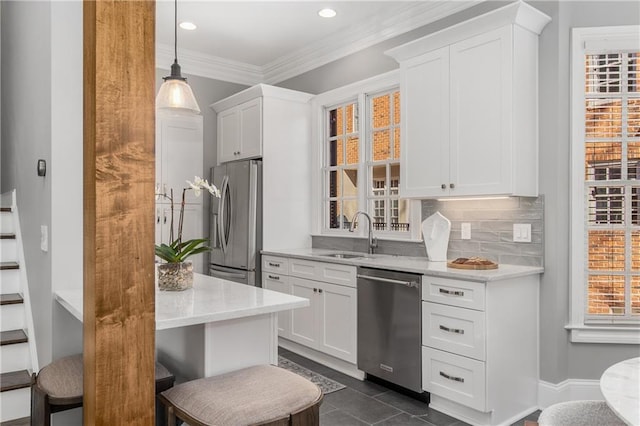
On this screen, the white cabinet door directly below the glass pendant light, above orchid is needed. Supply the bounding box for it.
[156,114,204,205]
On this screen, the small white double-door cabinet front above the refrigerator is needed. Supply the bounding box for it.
[218,98,262,163]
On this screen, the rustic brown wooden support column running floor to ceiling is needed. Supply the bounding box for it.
[83,0,155,426]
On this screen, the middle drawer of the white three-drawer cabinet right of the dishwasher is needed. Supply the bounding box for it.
[422,302,486,361]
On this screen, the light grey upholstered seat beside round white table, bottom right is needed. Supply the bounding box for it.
[538,401,625,426]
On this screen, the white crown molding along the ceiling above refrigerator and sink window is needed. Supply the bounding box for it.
[156,0,485,86]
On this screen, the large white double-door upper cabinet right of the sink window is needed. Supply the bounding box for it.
[387,2,550,198]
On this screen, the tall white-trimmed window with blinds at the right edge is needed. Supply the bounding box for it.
[570,27,640,343]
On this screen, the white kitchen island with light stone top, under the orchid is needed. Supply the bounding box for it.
[54,273,309,381]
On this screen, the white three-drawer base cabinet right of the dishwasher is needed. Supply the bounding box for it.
[422,275,539,426]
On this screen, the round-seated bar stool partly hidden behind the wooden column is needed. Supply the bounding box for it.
[31,354,175,426]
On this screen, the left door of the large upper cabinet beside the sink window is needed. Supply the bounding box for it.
[400,47,452,198]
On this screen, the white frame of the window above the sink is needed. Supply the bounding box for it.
[311,70,422,241]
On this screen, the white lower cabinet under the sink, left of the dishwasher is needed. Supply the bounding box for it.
[262,255,357,364]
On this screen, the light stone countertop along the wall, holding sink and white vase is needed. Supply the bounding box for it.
[262,248,544,282]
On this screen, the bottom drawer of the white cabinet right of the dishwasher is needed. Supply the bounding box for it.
[422,346,488,412]
